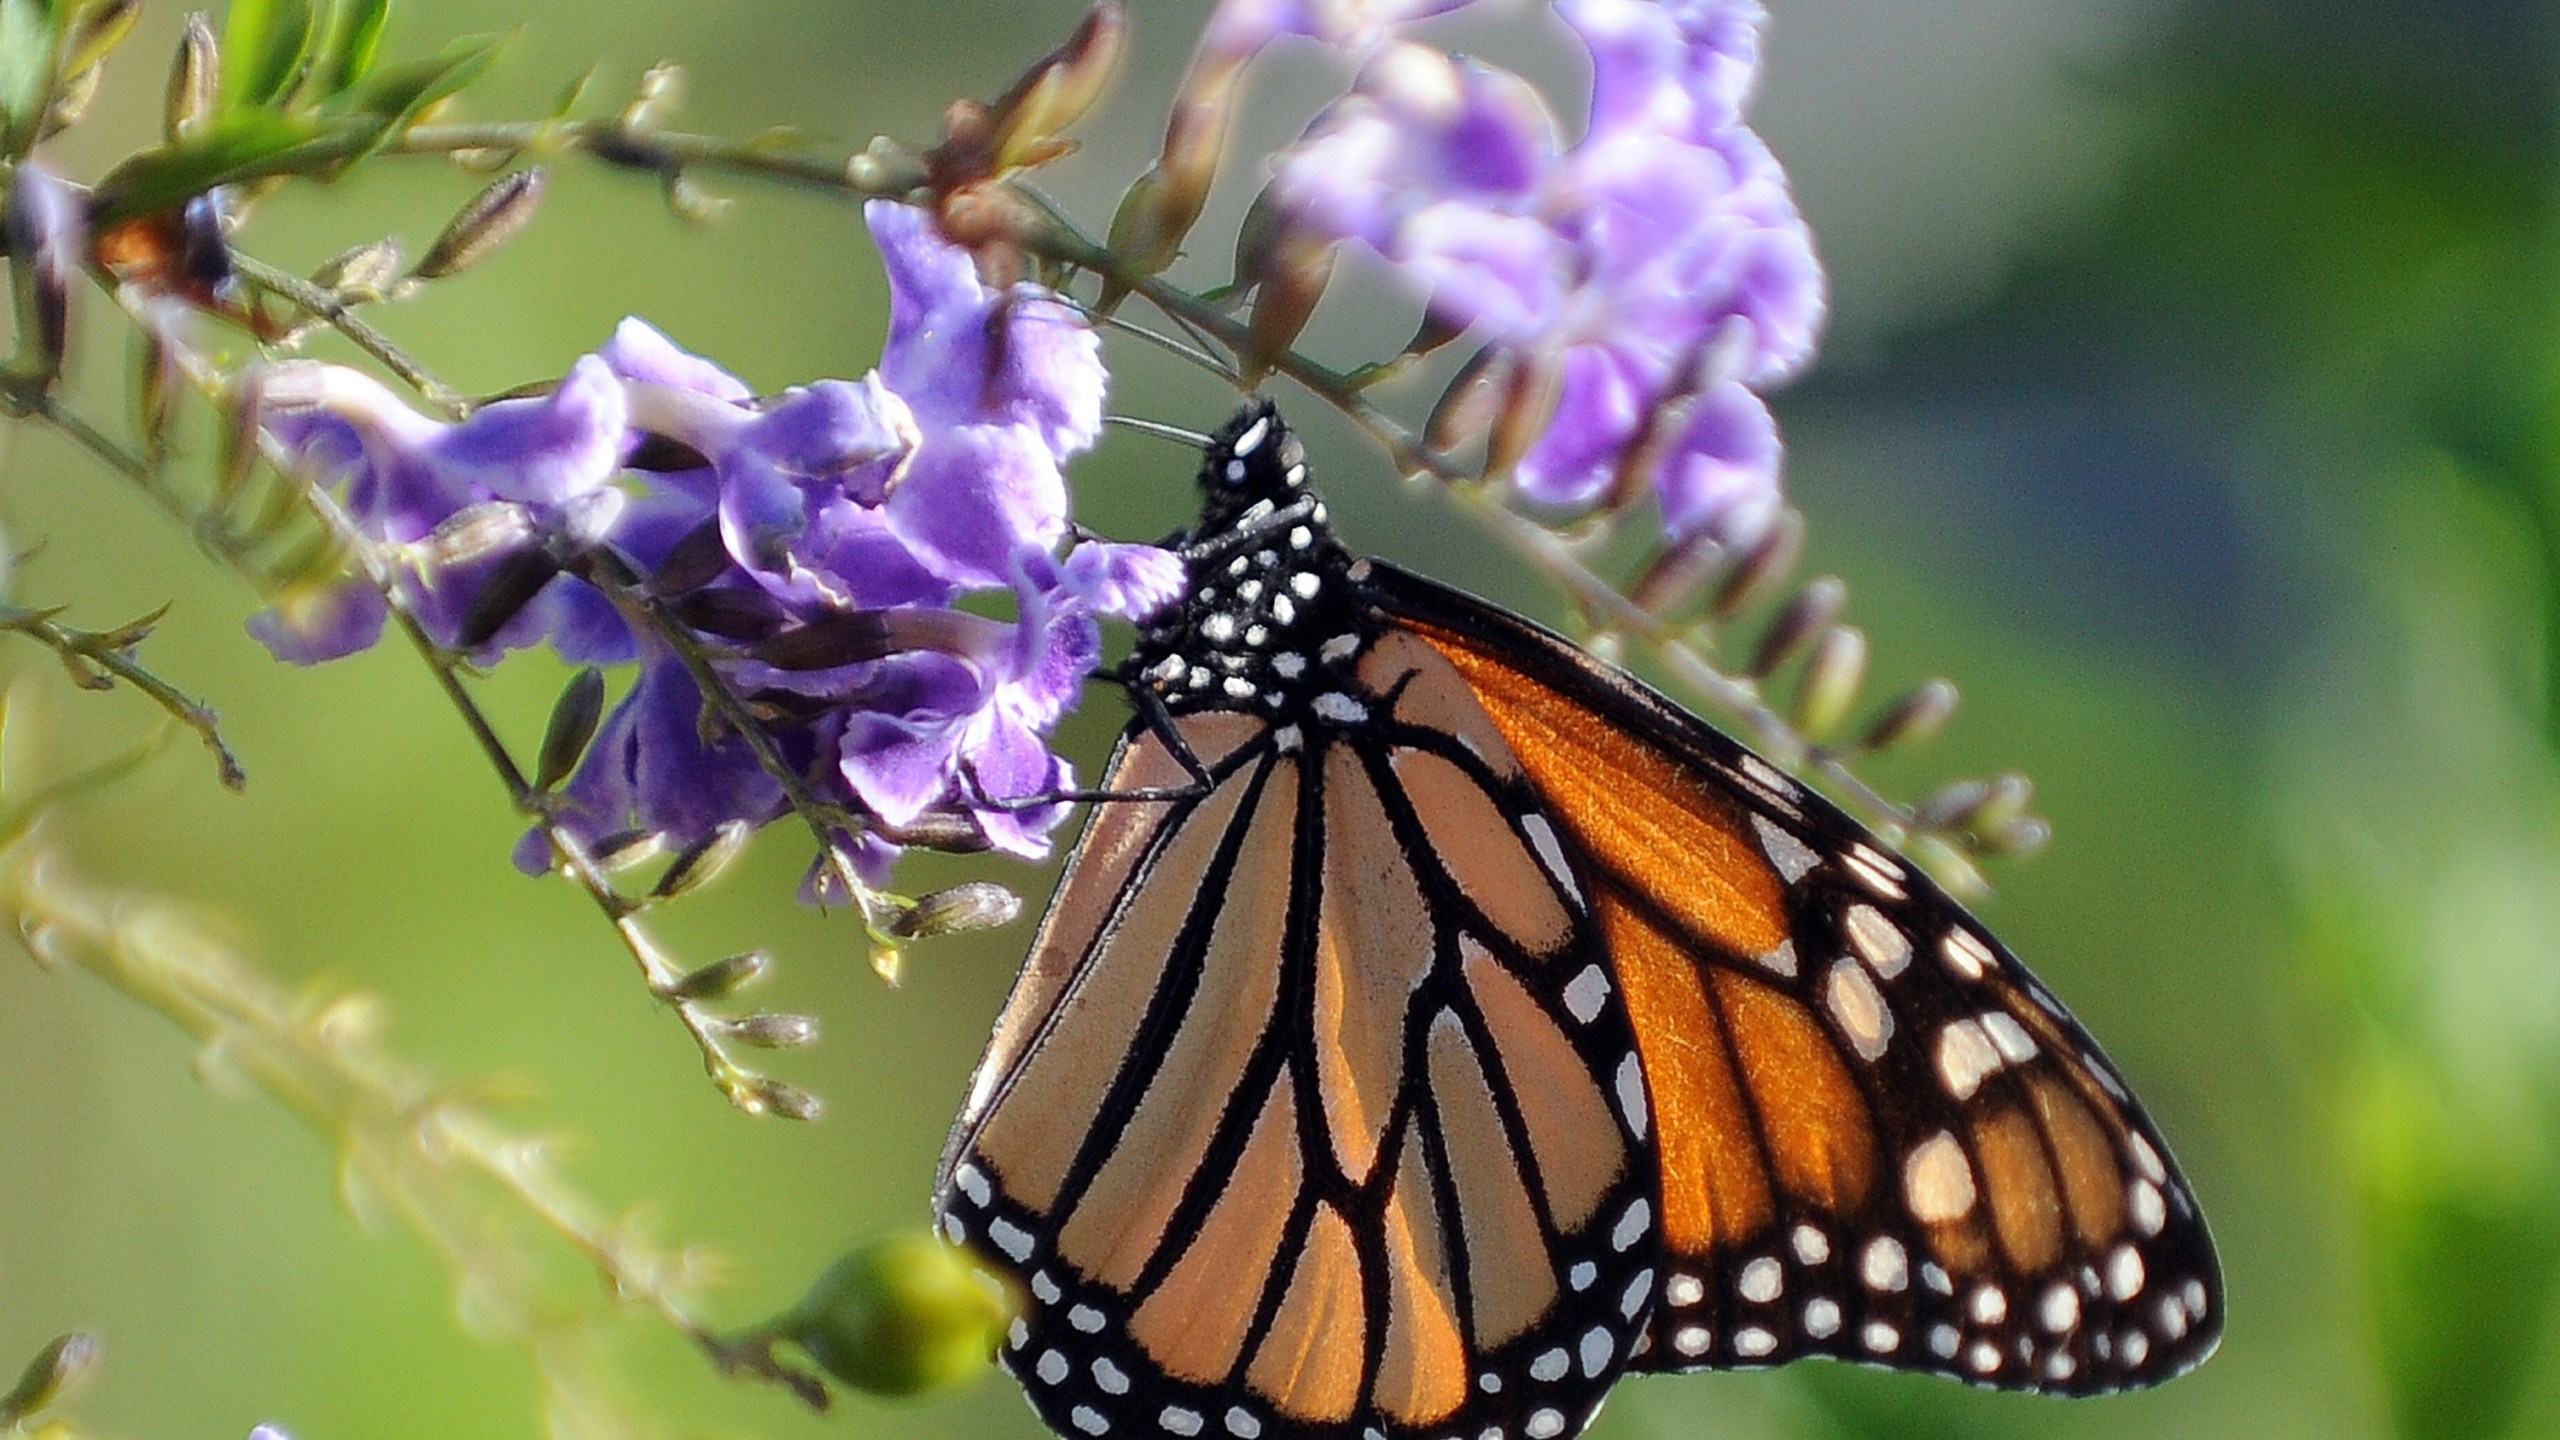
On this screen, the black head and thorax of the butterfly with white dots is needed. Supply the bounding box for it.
[1129,402,1362,717]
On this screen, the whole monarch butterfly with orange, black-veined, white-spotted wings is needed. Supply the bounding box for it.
[937,402,2222,1440]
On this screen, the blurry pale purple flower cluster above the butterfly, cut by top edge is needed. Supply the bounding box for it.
[1259,0,1823,543]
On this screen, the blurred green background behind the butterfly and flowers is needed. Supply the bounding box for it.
[0,0,2560,1440]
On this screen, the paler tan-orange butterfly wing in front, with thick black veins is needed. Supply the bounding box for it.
[937,676,1656,1440]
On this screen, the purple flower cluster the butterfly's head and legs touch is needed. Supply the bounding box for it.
[253,202,1183,879]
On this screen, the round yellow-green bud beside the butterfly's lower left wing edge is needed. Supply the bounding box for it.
[776,1230,1011,1394]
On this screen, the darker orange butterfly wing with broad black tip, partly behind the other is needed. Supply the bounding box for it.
[1354,564,2222,1394]
